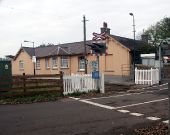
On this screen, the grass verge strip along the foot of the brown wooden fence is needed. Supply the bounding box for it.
[0,91,63,104]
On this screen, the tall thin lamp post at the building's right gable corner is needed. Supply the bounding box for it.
[129,13,136,80]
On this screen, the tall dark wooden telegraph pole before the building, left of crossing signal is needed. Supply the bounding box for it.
[83,15,88,74]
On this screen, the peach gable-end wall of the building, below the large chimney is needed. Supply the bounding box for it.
[101,38,130,76]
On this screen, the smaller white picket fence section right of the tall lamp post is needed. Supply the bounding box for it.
[135,68,159,85]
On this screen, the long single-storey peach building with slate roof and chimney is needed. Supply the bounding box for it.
[12,22,145,76]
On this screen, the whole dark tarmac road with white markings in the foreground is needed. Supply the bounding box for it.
[0,85,168,135]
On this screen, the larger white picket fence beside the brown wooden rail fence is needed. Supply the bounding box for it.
[63,74,104,95]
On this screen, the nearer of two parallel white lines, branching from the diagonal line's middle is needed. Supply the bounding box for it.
[114,98,169,109]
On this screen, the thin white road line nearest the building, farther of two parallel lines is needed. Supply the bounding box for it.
[84,88,168,100]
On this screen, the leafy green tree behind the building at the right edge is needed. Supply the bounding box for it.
[143,17,170,46]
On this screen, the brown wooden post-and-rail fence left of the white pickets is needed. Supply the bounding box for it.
[0,72,63,92]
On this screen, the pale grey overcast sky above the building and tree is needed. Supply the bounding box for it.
[0,0,170,57]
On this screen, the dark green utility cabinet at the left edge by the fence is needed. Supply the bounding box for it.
[0,60,12,91]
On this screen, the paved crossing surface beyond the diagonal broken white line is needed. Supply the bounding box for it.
[79,84,169,123]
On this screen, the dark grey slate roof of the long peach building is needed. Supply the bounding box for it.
[22,35,143,58]
